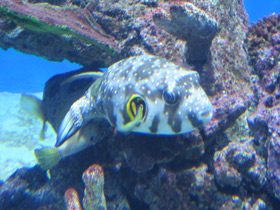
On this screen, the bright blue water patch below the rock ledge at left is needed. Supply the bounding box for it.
[0,49,81,93]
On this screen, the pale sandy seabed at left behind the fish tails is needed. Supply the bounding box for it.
[0,92,56,181]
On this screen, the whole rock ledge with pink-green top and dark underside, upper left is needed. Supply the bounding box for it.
[0,0,120,65]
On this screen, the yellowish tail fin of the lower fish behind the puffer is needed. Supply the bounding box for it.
[34,147,62,170]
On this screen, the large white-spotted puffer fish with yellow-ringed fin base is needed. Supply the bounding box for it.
[56,55,213,146]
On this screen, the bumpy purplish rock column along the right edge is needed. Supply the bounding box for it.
[247,14,280,199]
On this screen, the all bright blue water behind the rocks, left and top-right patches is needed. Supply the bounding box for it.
[0,0,280,92]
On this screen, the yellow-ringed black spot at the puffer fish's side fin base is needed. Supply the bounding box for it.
[126,94,146,120]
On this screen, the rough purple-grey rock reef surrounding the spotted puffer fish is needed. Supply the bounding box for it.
[0,0,280,210]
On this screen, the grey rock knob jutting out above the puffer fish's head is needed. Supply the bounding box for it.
[153,1,218,64]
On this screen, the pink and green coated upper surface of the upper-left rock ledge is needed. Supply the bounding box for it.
[0,0,120,56]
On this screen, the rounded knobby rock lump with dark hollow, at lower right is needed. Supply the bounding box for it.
[214,141,266,190]
